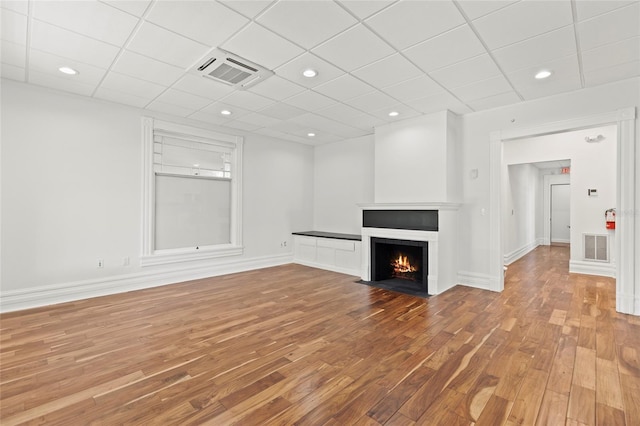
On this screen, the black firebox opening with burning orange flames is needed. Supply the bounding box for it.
[371,237,429,296]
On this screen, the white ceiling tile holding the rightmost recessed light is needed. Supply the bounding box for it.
[507,55,581,100]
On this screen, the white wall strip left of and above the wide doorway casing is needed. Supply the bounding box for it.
[459,78,640,278]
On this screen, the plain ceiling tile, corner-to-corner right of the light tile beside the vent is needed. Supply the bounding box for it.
[352,54,423,87]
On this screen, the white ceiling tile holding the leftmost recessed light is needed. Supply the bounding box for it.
[29,49,107,87]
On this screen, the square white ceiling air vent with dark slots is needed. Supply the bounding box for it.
[196,49,273,89]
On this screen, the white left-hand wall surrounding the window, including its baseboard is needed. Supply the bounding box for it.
[1,80,313,309]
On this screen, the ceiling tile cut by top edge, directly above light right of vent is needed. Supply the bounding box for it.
[257,1,358,49]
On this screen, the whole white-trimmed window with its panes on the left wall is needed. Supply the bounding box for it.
[141,117,243,266]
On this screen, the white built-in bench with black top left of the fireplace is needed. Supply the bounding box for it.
[292,231,362,276]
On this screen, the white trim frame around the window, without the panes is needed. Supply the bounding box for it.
[140,117,244,266]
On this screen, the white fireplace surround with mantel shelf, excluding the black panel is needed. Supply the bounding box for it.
[359,203,460,295]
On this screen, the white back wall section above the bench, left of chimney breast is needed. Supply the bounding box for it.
[312,135,374,234]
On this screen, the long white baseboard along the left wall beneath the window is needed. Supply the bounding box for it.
[0,253,293,312]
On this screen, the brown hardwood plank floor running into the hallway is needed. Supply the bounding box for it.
[0,247,640,426]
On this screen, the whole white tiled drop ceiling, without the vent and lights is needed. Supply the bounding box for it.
[0,0,640,144]
